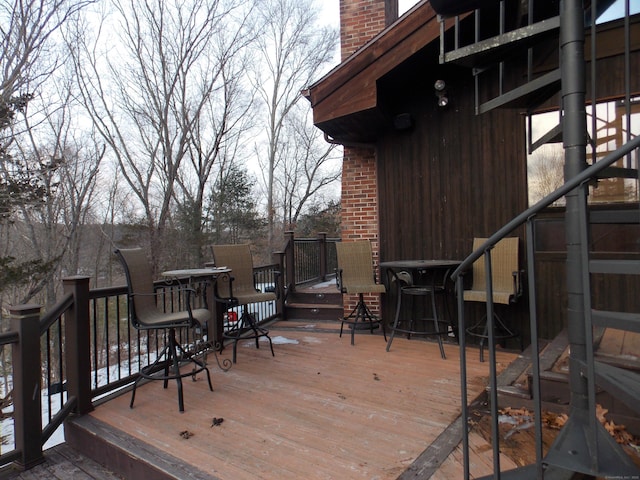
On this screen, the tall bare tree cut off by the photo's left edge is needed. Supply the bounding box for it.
[0,0,93,303]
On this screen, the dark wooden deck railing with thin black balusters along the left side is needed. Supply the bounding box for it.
[0,264,282,470]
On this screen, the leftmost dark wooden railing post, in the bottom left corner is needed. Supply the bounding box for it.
[9,305,44,470]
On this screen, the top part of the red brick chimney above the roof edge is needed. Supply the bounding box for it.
[338,0,398,60]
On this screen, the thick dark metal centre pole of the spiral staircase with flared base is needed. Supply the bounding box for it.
[545,0,638,478]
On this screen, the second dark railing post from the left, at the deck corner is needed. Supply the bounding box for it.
[62,276,93,414]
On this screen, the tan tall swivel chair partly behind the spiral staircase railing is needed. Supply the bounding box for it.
[463,237,522,362]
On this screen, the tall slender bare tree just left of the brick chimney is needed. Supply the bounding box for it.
[253,0,338,247]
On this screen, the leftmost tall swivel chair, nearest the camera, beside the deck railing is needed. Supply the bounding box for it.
[115,248,213,412]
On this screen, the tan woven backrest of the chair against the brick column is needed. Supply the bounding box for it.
[336,240,376,293]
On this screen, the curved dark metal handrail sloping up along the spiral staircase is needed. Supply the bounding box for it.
[451,136,640,280]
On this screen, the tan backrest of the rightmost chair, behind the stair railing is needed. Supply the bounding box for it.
[471,237,519,303]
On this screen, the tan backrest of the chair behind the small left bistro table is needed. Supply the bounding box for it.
[211,244,256,298]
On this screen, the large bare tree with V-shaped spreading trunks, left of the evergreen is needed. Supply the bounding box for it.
[69,0,255,265]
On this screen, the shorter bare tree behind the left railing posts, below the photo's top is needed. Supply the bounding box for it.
[5,75,104,305]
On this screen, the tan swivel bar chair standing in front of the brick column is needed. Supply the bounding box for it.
[336,240,387,345]
